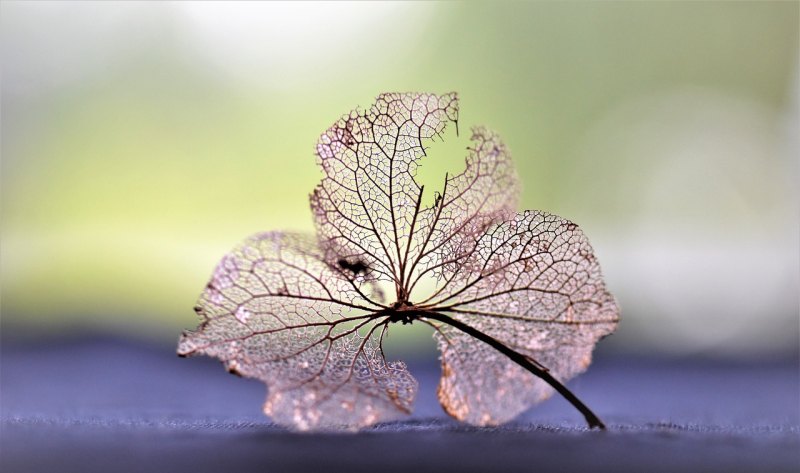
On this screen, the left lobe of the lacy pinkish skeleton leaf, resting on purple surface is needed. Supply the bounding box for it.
[178,233,417,430]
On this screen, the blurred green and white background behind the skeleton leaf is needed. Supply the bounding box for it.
[0,1,800,356]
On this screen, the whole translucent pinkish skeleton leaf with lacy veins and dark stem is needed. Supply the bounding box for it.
[178,90,619,430]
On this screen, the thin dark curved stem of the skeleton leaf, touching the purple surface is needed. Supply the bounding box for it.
[418,311,606,430]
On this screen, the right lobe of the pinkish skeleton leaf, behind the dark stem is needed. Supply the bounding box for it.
[430,211,618,425]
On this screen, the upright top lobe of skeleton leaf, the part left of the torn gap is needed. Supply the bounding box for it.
[311,94,458,286]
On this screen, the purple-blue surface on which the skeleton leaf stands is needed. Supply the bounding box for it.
[0,339,800,473]
